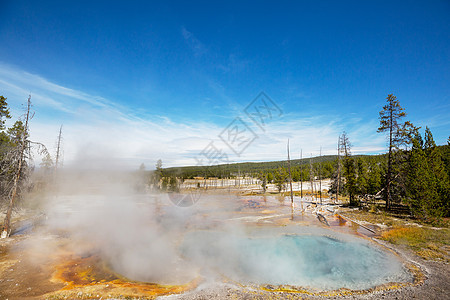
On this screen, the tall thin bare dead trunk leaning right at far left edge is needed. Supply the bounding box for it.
[1,96,31,238]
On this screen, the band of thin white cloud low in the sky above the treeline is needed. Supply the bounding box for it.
[0,65,384,168]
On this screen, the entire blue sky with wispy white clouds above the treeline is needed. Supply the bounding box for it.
[0,0,450,167]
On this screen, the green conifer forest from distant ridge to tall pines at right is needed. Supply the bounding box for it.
[152,94,450,222]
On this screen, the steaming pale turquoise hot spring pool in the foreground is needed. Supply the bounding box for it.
[182,229,413,290]
